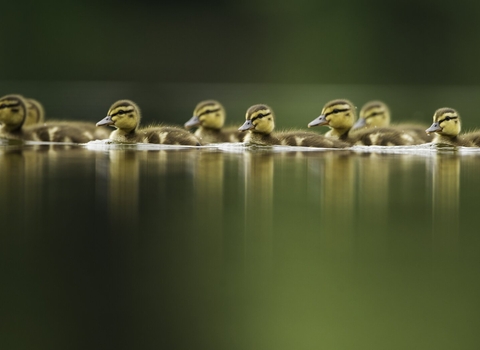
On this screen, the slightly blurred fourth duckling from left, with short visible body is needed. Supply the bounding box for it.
[185,100,245,144]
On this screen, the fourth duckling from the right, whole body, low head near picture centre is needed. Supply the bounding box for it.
[238,104,349,148]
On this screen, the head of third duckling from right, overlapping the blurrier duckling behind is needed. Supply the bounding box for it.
[308,99,357,134]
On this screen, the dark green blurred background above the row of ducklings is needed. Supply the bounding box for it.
[0,0,480,127]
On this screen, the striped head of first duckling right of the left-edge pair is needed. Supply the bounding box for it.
[97,100,141,133]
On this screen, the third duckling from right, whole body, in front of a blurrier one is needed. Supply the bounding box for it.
[308,99,424,146]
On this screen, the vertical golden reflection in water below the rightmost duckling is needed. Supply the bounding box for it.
[430,154,460,253]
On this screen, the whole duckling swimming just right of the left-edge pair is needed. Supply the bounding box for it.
[97,100,200,146]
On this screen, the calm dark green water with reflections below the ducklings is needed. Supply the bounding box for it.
[0,145,480,349]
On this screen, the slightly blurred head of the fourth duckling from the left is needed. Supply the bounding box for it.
[184,100,225,129]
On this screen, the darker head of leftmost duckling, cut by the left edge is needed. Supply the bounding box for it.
[0,95,27,131]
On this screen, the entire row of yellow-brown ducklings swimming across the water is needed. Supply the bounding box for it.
[0,95,480,148]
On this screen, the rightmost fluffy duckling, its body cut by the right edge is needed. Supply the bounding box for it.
[425,108,480,147]
